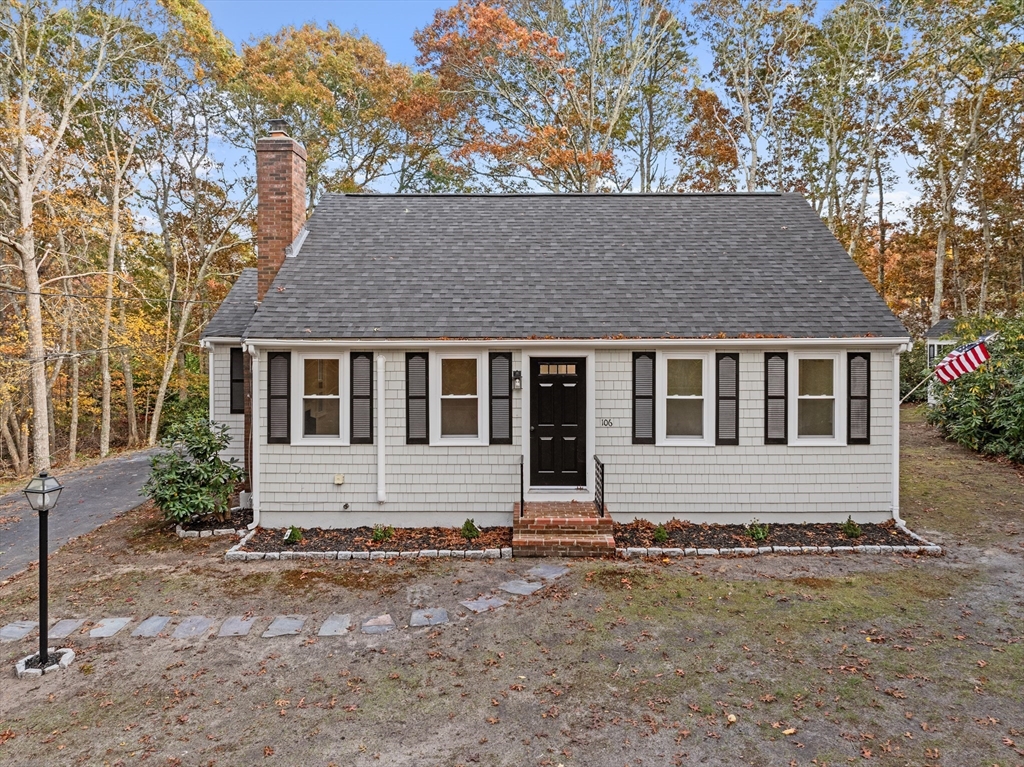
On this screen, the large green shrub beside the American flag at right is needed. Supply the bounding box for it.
[928,317,1024,463]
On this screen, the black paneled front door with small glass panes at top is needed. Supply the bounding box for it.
[529,357,587,487]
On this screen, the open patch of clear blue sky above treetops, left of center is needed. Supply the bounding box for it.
[205,0,454,65]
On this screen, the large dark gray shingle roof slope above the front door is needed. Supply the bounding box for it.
[239,195,907,339]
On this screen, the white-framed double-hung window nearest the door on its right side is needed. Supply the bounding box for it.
[655,352,715,444]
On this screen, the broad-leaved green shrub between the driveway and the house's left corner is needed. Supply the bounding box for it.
[140,417,245,524]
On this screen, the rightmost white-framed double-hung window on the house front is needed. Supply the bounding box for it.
[790,352,846,444]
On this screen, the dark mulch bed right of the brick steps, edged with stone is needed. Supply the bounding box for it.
[614,519,921,549]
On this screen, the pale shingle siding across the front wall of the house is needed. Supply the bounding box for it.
[256,345,896,526]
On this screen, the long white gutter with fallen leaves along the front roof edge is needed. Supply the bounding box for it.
[245,336,912,352]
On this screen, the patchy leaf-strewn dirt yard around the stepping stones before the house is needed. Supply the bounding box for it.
[0,410,1024,767]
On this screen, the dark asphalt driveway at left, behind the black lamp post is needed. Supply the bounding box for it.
[0,449,157,582]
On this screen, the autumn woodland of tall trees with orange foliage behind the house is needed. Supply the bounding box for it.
[0,0,1024,476]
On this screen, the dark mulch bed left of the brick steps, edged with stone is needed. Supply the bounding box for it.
[243,527,512,552]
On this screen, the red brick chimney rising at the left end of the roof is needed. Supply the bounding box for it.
[256,120,306,301]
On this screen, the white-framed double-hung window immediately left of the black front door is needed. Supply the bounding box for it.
[430,352,487,444]
